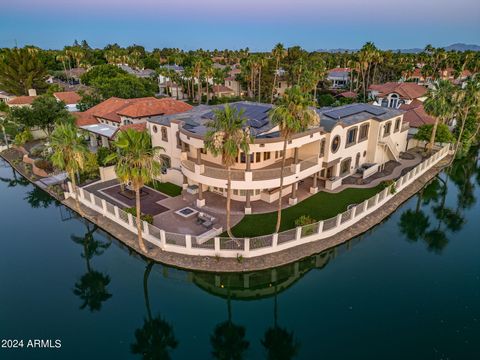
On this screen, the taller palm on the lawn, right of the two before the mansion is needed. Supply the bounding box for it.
[269,85,319,233]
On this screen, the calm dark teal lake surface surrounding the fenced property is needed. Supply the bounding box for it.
[0,151,480,360]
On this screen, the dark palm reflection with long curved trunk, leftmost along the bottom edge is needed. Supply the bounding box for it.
[130,261,178,360]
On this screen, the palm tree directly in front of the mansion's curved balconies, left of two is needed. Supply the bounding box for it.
[205,105,252,238]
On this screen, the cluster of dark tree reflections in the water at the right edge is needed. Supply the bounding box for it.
[398,148,480,254]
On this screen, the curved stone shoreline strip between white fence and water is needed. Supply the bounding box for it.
[2,146,451,272]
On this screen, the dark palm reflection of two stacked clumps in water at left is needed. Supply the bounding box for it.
[70,220,112,312]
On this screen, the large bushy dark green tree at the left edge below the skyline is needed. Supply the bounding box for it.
[0,48,48,95]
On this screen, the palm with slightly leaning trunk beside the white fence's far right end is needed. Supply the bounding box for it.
[424,80,454,152]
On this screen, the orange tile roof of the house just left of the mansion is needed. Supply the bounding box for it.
[76,97,192,126]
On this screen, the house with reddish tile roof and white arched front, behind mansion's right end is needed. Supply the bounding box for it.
[368,82,427,109]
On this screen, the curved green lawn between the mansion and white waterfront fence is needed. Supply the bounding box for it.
[232,185,384,237]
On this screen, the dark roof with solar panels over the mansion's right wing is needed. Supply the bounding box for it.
[317,104,403,132]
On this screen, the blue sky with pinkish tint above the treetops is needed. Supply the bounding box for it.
[0,0,480,51]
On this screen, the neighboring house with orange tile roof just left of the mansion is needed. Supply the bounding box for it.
[75,97,192,151]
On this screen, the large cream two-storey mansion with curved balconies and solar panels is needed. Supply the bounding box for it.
[147,101,408,213]
